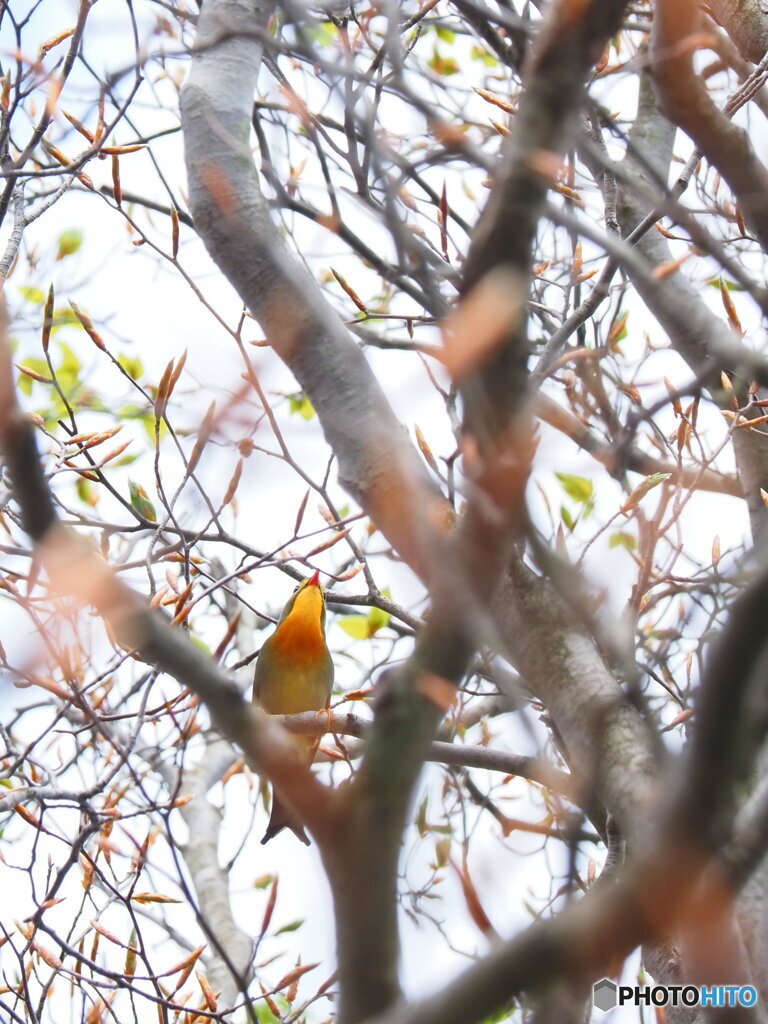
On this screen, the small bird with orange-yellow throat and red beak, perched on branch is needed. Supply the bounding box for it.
[253,571,334,846]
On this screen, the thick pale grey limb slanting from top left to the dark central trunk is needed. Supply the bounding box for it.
[181,0,441,593]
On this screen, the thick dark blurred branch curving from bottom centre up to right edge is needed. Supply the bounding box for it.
[358,557,768,1024]
